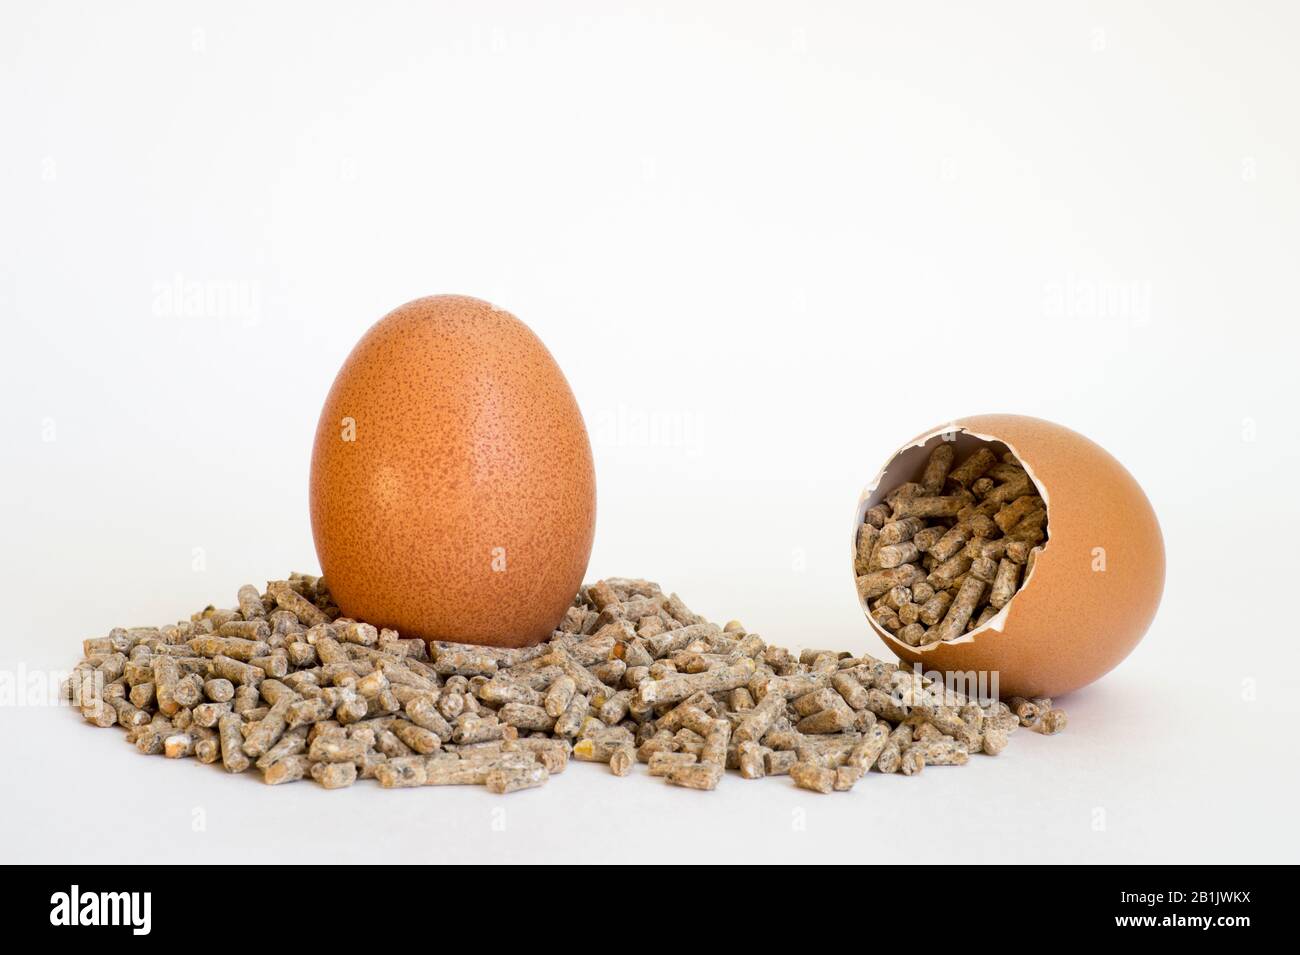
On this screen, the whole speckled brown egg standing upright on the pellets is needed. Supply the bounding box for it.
[311,295,595,647]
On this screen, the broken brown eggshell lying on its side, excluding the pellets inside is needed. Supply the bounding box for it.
[854,414,1165,696]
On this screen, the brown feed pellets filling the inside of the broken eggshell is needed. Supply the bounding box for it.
[854,440,1048,647]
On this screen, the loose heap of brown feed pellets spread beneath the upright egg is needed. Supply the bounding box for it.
[65,574,1065,793]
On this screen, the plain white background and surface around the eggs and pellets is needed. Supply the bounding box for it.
[0,1,1300,863]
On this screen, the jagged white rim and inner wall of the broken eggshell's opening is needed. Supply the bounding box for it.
[849,425,1052,654]
